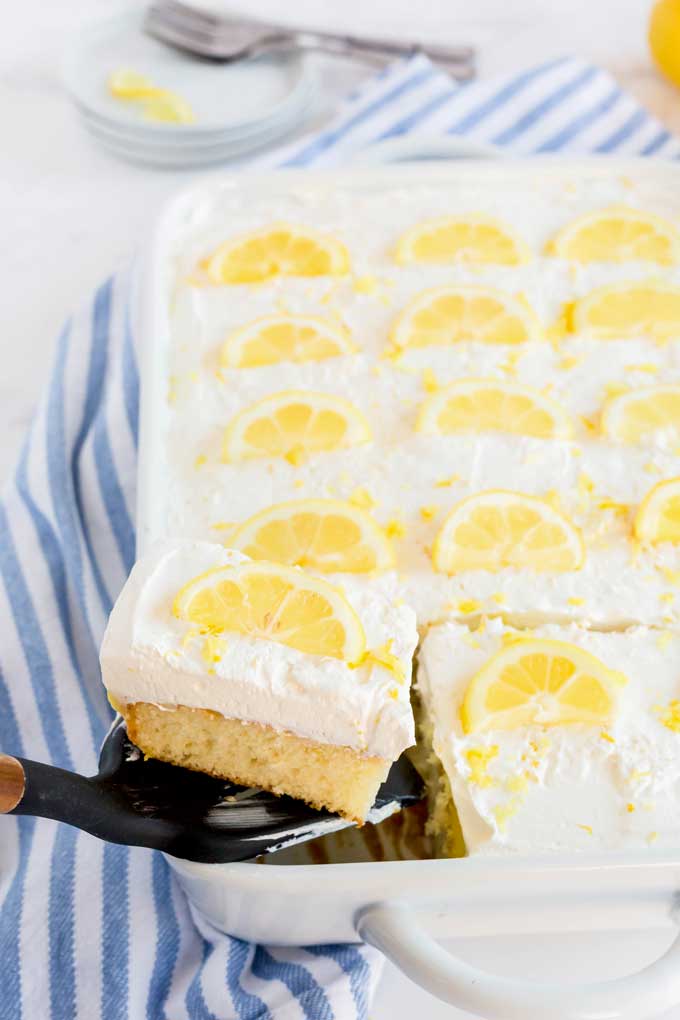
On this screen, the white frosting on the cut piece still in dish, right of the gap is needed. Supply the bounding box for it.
[418,620,680,854]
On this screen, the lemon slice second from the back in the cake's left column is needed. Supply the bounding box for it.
[221,315,356,368]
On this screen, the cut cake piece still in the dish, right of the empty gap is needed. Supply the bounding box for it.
[417,620,680,855]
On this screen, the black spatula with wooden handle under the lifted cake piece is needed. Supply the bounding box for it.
[0,719,423,863]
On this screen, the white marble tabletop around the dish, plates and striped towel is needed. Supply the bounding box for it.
[0,0,680,1020]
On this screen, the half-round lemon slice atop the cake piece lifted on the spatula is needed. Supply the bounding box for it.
[172,562,366,663]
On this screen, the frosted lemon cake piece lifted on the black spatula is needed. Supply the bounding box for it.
[101,542,417,822]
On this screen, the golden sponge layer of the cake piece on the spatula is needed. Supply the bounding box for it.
[122,703,391,824]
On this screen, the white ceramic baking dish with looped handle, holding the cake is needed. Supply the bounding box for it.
[138,159,680,1020]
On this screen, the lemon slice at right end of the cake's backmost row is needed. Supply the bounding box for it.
[547,206,680,265]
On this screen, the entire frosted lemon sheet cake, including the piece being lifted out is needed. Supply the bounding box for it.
[114,167,680,853]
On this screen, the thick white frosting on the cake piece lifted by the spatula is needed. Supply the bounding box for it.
[101,542,417,760]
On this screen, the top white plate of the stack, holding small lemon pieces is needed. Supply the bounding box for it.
[63,9,311,138]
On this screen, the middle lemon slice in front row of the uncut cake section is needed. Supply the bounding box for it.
[432,489,584,573]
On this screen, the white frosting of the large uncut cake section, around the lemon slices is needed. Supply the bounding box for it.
[147,168,680,626]
